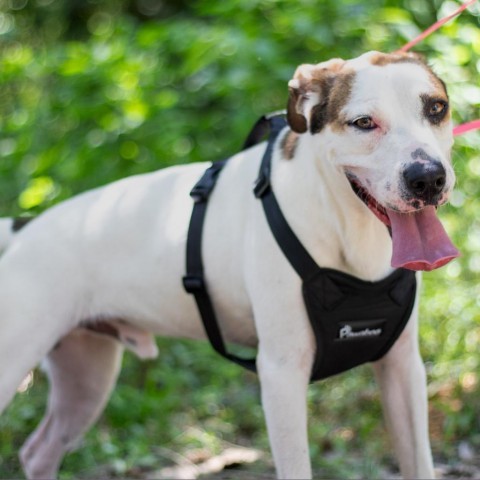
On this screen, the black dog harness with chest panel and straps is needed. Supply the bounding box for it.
[183,115,416,381]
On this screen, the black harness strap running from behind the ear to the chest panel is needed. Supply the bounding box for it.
[253,115,318,280]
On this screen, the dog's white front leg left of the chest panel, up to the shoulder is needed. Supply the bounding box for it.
[245,217,316,479]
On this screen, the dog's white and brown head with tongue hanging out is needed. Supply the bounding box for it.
[287,52,458,270]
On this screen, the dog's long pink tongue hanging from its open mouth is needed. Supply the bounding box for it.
[387,206,460,270]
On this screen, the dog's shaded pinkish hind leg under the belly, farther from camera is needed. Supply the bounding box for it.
[20,328,123,479]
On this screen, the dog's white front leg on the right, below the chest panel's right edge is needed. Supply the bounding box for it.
[374,298,434,479]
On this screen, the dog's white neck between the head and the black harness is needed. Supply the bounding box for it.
[272,129,392,281]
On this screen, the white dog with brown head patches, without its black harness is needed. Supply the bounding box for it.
[0,52,457,479]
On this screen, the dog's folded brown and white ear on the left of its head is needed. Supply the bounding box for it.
[287,58,345,133]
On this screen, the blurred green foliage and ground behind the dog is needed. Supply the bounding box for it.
[0,0,480,479]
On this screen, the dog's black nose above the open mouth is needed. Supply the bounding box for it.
[403,161,447,204]
